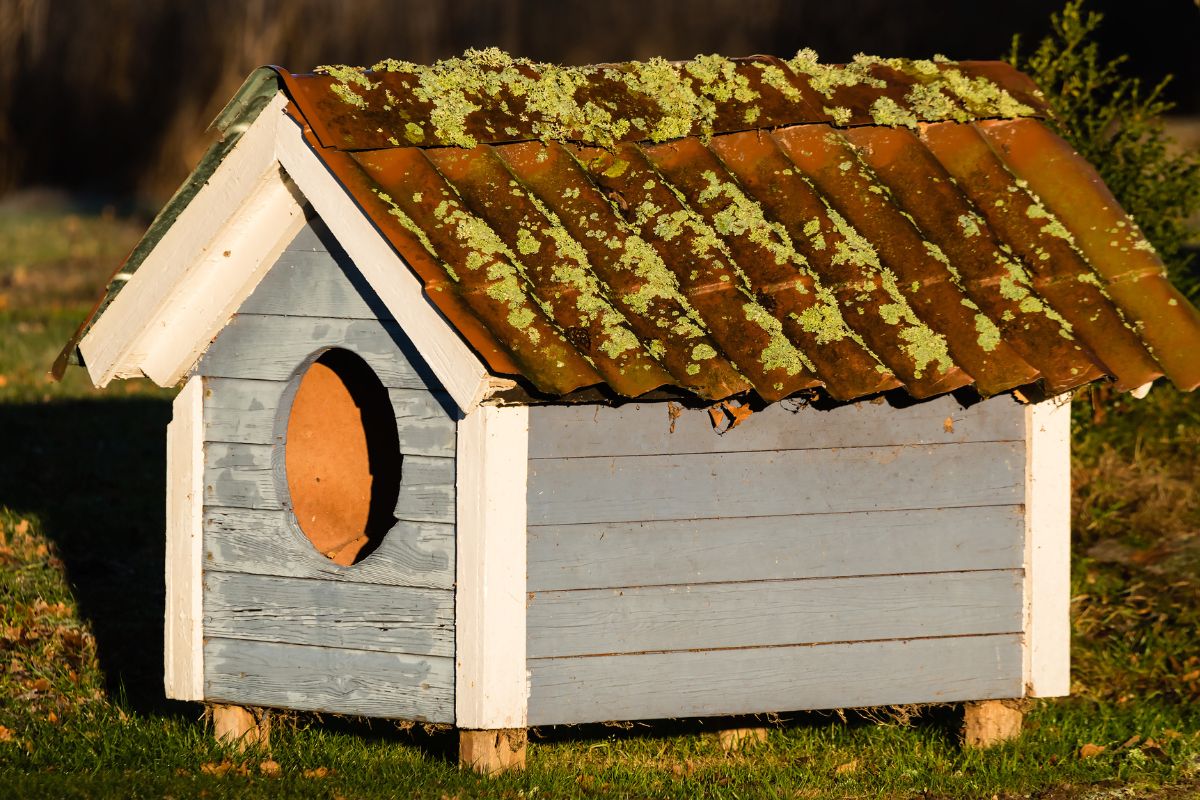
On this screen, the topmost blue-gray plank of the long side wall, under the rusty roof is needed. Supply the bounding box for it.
[529,395,1025,458]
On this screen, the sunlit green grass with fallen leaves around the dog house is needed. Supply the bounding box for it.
[0,209,1200,800]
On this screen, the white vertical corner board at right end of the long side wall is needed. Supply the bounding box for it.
[1025,395,1070,697]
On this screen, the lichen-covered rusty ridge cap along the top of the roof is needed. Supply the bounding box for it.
[280,48,1049,151]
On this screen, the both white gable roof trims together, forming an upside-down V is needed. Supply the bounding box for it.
[79,91,501,414]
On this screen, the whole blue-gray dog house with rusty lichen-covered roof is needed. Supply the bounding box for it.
[59,50,1200,760]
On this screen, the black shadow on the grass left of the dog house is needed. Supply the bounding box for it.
[0,397,182,714]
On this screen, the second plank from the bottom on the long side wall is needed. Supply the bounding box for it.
[526,570,1024,658]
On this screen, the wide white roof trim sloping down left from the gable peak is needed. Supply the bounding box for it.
[79,92,305,386]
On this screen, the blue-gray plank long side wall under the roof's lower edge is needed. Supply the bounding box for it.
[527,397,1025,724]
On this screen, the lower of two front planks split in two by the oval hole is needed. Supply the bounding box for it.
[204,441,455,523]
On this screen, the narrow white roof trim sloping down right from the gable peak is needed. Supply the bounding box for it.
[276,118,499,415]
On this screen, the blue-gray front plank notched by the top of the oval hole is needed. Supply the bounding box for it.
[198,313,443,391]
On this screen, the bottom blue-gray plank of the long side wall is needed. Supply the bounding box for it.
[527,634,1022,726]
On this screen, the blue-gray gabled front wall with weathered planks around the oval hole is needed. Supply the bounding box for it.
[198,222,457,722]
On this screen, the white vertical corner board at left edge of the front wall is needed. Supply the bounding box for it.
[163,375,204,700]
